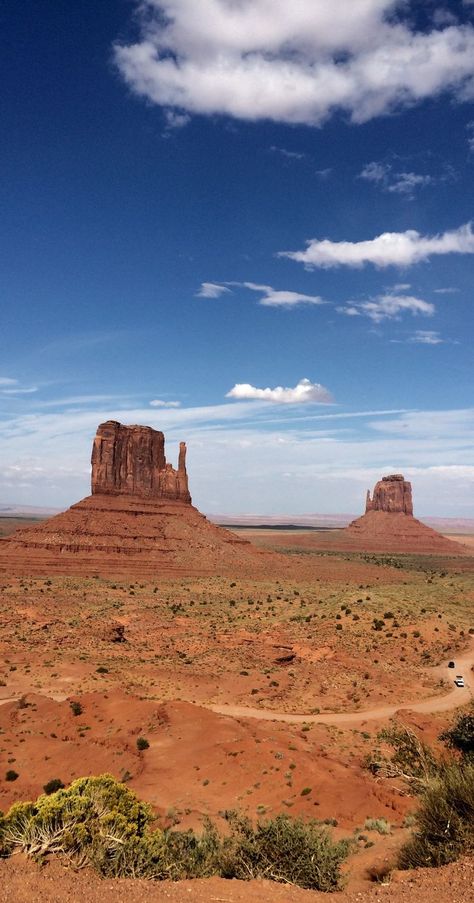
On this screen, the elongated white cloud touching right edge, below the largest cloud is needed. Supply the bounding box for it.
[279,223,474,269]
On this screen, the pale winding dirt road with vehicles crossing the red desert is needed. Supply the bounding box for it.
[208,643,474,726]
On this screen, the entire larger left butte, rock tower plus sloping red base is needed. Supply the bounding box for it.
[0,420,280,578]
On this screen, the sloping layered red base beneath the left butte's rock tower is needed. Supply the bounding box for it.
[0,494,279,578]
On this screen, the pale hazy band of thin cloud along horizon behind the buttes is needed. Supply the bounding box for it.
[0,400,474,517]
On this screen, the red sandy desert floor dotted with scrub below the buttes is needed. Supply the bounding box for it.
[0,531,474,903]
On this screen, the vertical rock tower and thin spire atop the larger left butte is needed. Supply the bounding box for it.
[92,420,191,503]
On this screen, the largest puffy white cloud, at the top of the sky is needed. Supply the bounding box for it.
[115,0,474,125]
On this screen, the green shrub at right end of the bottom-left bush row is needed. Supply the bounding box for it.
[221,814,349,891]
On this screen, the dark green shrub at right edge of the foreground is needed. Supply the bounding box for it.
[399,764,474,868]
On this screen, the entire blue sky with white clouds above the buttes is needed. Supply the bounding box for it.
[0,0,474,517]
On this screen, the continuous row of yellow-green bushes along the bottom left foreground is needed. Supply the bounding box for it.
[0,775,349,891]
